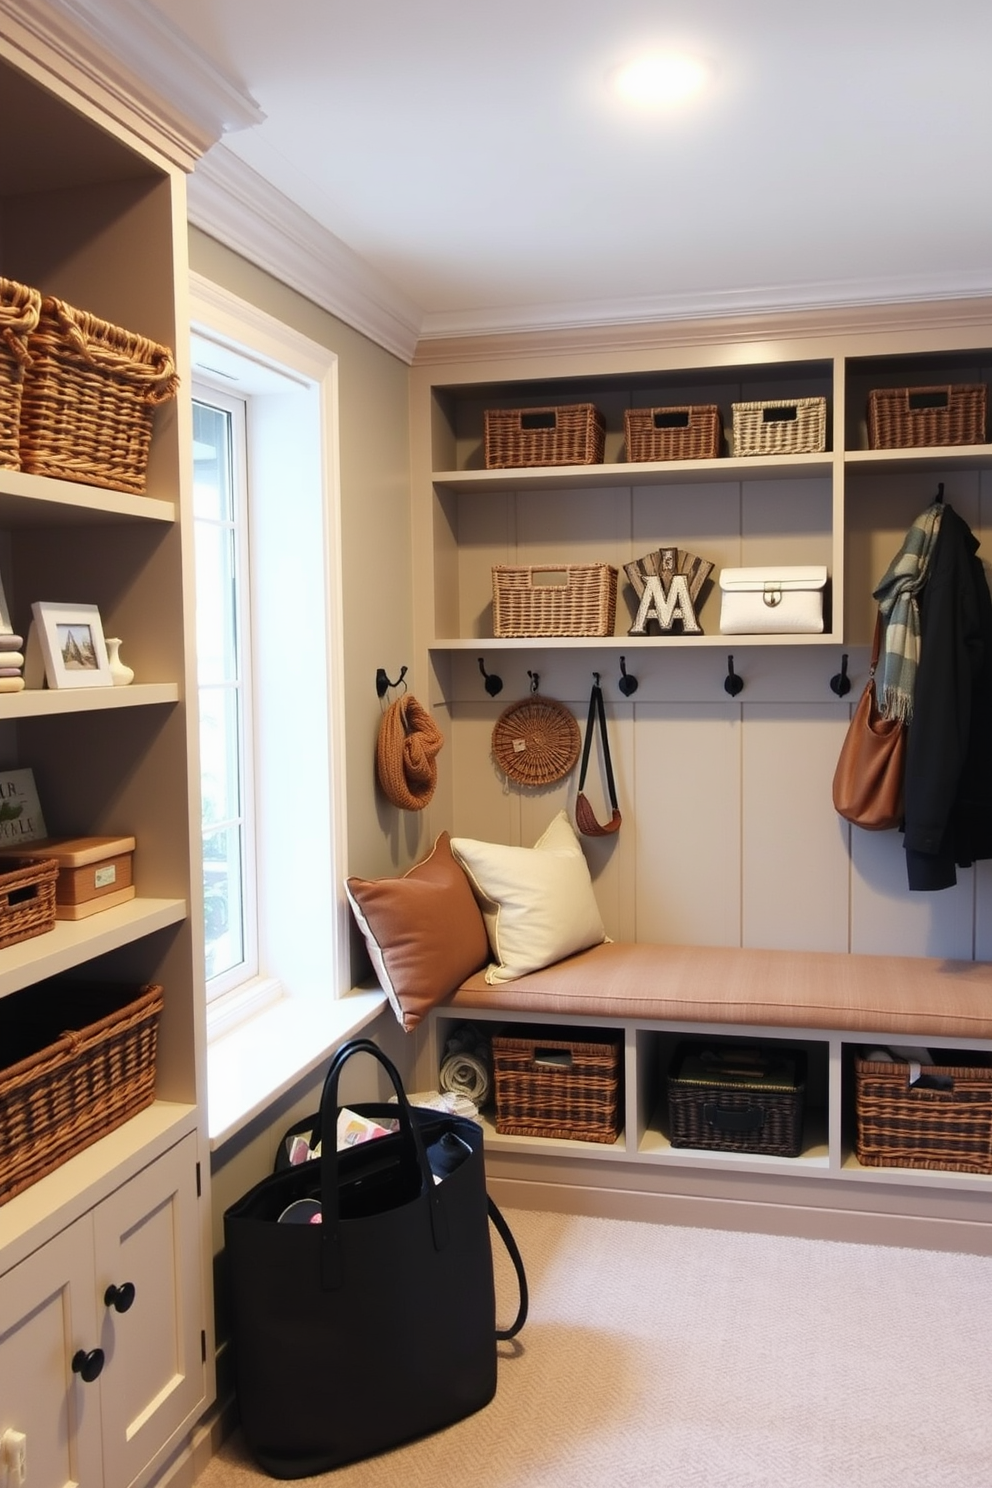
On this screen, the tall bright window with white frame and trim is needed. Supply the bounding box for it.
[192,278,350,1039]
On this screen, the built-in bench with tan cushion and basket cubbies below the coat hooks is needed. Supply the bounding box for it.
[422,942,992,1254]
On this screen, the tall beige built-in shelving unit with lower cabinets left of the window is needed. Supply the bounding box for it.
[0,37,214,1488]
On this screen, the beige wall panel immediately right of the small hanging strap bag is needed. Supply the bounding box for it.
[633,704,741,945]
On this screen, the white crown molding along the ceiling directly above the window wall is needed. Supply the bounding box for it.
[187,144,422,365]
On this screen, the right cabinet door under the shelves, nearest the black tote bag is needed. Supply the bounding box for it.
[91,1135,205,1488]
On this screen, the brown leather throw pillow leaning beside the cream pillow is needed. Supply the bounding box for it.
[345,832,489,1033]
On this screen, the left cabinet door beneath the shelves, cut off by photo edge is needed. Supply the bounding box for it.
[0,1216,103,1488]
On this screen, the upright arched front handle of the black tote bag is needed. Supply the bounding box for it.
[317,1039,448,1292]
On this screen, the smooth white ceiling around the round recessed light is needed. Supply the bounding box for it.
[133,0,992,335]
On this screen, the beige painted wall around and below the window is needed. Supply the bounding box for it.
[189,229,425,1363]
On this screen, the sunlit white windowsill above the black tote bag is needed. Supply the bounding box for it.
[207,987,387,1152]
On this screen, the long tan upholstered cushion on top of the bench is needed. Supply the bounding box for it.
[443,942,992,1042]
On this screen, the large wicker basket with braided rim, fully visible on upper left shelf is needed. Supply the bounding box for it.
[21,298,178,496]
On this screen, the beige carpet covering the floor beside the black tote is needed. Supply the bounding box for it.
[198,1211,992,1488]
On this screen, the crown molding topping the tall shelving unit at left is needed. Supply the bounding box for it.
[0,0,265,171]
